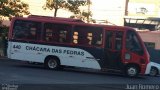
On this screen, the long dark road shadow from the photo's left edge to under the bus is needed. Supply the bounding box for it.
[0,59,146,79]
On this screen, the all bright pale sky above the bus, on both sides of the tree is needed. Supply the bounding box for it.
[22,0,125,24]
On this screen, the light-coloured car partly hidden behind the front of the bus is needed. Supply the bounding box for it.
[146,61,160,76]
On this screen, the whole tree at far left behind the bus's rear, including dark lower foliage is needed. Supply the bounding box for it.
[0,0,30,48]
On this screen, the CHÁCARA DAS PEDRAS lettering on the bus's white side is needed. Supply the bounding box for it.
[26,46,84,56]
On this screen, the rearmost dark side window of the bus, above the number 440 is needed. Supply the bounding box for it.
[13,20,41,40]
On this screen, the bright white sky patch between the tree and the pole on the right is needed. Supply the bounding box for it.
[91,0,125,20]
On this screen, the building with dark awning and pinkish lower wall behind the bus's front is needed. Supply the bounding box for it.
[124,0,160,50]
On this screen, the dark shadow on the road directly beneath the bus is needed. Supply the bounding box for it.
[14,61,145,79]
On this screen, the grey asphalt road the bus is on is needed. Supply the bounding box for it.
[0,58,160,90]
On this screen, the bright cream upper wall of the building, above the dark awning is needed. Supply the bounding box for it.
[127,0,160,17]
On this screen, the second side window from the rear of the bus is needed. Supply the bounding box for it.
[44,23,72,43]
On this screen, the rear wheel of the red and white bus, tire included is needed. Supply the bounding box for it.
[44,57,60,70]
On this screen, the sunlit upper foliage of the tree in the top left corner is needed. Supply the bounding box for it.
[0,0,30,19]
